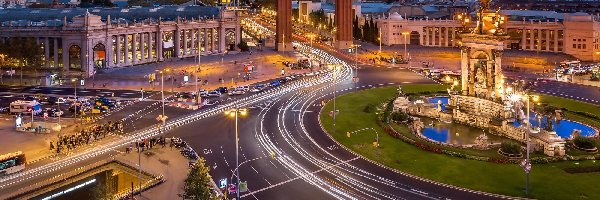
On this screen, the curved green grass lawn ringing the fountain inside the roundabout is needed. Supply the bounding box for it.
[320,86,600,199]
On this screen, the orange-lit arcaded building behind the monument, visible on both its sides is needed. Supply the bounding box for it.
[376,10,600,61]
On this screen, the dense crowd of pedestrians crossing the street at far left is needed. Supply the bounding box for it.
[50,121,123,154]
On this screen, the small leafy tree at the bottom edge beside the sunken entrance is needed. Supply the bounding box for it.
[182,158,216,200]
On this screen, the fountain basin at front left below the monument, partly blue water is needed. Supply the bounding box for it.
[421,117,504,145]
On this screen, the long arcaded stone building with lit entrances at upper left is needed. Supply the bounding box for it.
[0,6,241,77]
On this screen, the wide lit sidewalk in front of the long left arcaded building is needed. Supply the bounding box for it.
[88,49,304,91]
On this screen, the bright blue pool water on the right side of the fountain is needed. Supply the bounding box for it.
[513,113,596,138]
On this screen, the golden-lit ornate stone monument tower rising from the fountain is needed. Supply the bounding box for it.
[460,0,508,100]
